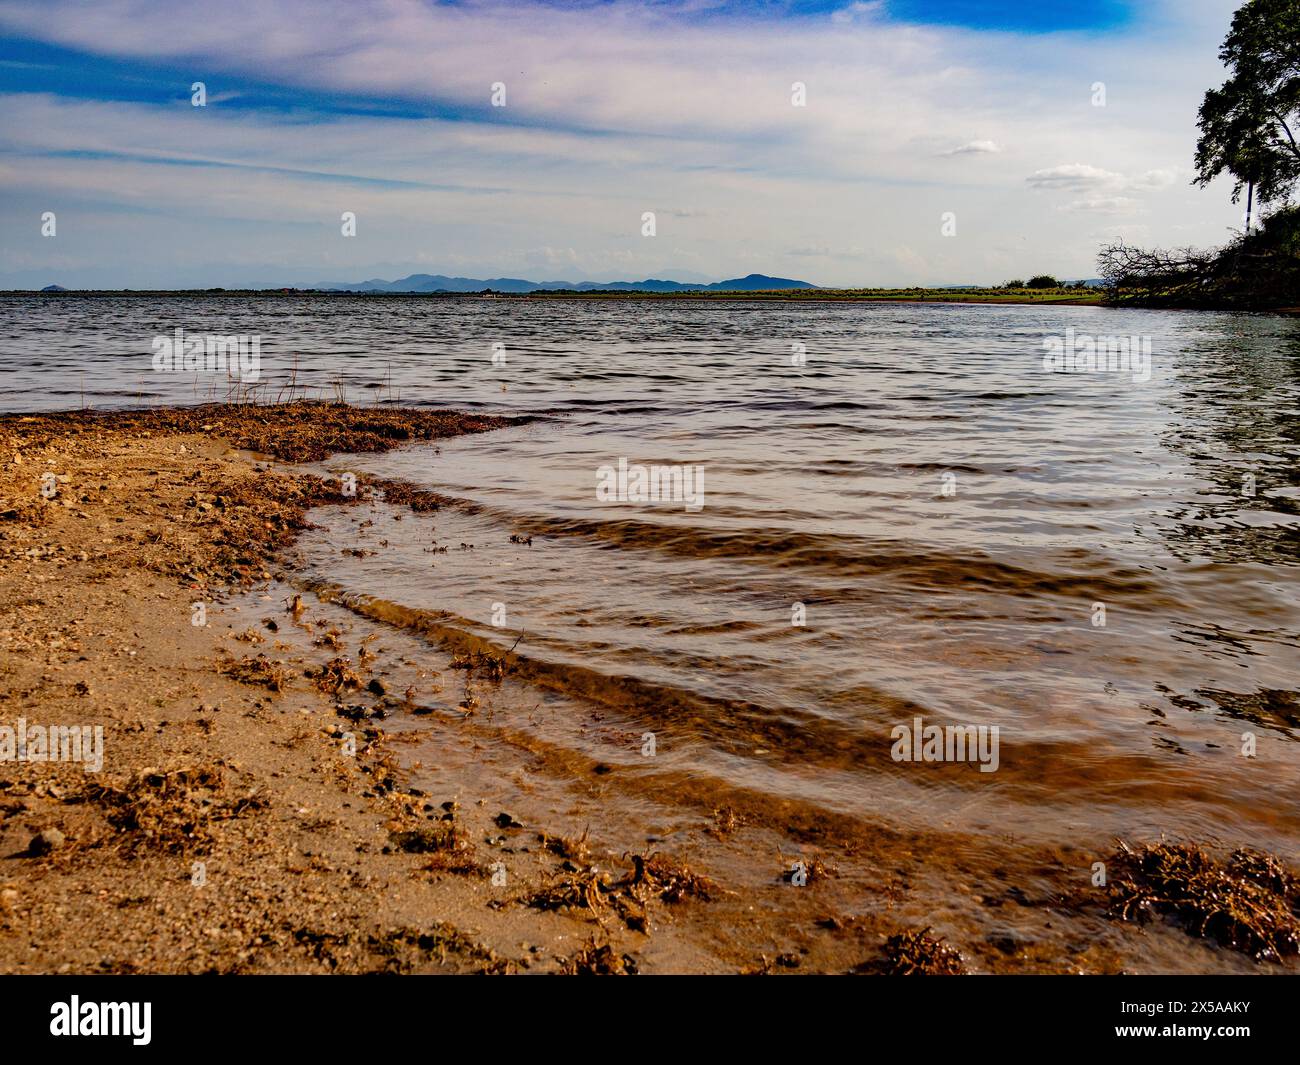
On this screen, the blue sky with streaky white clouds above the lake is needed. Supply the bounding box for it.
[0,0,1243,289]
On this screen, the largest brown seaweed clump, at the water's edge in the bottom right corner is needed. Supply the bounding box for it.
[1110,843,1300,961]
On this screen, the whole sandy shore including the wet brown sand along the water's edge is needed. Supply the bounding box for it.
[0,404,1295,973]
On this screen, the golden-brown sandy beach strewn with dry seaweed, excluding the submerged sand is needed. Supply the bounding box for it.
[0,404,894,974]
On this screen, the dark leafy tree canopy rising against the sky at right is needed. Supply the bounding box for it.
[1195,0,1300,203]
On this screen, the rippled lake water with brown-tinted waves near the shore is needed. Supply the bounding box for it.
[0,296,1300,854]
